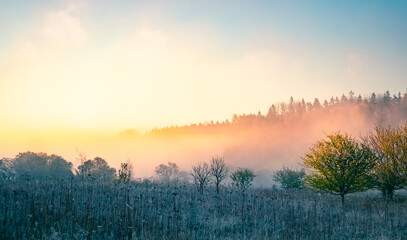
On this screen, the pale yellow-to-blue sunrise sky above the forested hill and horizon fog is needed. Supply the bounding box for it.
[0,0,407,135]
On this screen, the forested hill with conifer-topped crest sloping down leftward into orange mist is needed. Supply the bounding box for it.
[146,91,407,139]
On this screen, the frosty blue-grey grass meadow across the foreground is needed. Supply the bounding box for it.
[0,182,407,239]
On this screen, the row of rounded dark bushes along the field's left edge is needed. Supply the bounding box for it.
[0,152,127,182]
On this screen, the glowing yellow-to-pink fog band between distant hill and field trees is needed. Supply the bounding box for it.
[0,101,382,180]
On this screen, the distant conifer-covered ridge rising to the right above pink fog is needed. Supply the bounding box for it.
[145,91,407,136]
